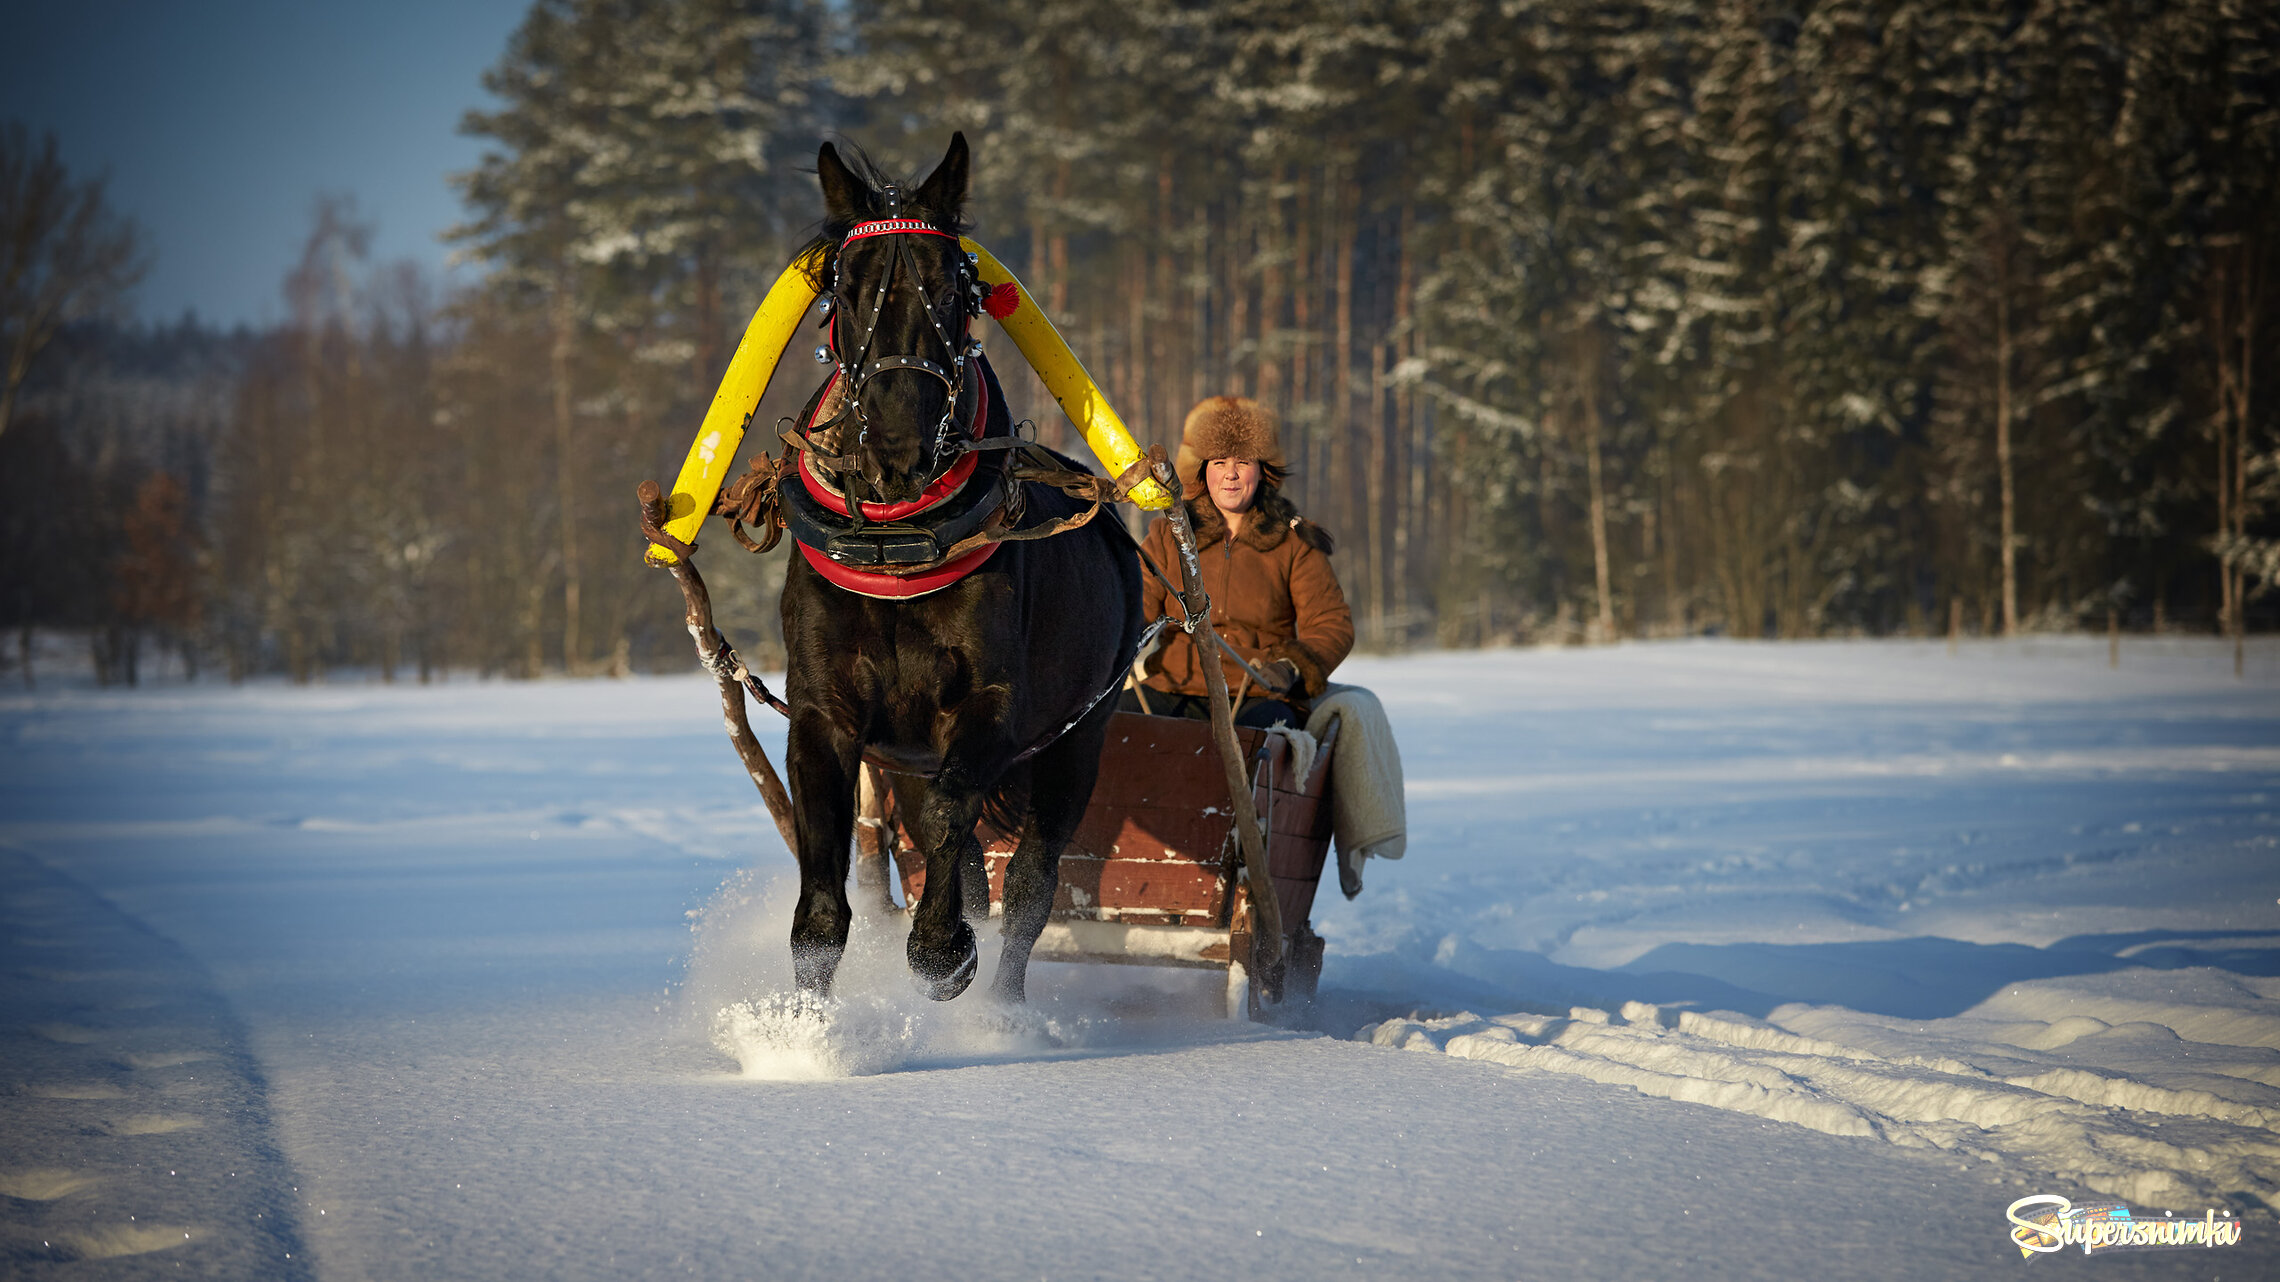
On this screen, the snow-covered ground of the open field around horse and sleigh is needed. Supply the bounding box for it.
[0,639,2280,1277]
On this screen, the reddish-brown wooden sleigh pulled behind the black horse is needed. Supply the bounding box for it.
[857,712,1338,1020]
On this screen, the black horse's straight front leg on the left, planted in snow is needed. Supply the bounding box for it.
[784,705,862,995]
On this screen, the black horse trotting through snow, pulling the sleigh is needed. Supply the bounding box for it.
[782,135,1140,1001]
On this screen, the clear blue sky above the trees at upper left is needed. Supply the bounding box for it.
[0,0,529,324]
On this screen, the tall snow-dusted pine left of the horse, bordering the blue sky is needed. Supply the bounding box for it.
[454,0,828,671]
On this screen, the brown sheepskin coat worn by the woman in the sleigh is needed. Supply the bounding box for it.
[1140,484,1354,700]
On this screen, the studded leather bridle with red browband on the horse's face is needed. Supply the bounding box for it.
[816,182,983,485]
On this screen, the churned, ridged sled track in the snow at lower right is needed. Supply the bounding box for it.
[1354,985,2280,1209]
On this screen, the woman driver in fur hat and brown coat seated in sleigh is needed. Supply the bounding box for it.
[1119,397,1354,725]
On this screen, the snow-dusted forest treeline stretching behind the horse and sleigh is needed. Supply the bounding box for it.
[0,0,2280,680]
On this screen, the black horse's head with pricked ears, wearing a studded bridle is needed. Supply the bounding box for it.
[816,132,978,502]
